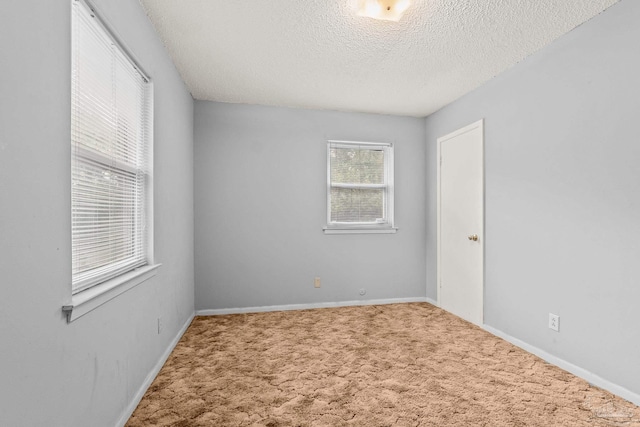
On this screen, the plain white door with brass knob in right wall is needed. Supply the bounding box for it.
[438,120,484,325]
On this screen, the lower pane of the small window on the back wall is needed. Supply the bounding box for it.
[331,188,384,222]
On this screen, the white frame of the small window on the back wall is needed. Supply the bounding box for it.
[323,140,397,234]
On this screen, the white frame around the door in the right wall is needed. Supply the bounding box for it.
[436,119,486,326]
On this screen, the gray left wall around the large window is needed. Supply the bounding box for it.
[0,0,194,427]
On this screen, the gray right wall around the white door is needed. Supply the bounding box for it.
[426,0,640,400]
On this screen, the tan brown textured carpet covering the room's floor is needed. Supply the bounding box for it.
[127,303,640,427]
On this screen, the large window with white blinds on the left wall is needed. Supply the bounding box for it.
[71,0,153,294]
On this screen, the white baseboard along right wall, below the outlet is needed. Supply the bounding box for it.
[483,325,640,406]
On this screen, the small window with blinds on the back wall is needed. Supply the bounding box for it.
[326,141,393,230]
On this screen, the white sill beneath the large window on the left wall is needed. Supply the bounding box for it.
[62,264,162,323]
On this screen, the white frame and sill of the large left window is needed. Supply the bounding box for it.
[62,0,160,322]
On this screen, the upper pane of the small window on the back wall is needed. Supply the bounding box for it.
[330,146,384,184]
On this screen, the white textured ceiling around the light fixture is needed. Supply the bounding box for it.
[140,0,618,117]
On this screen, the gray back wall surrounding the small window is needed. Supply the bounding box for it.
[194,101,426,310]
